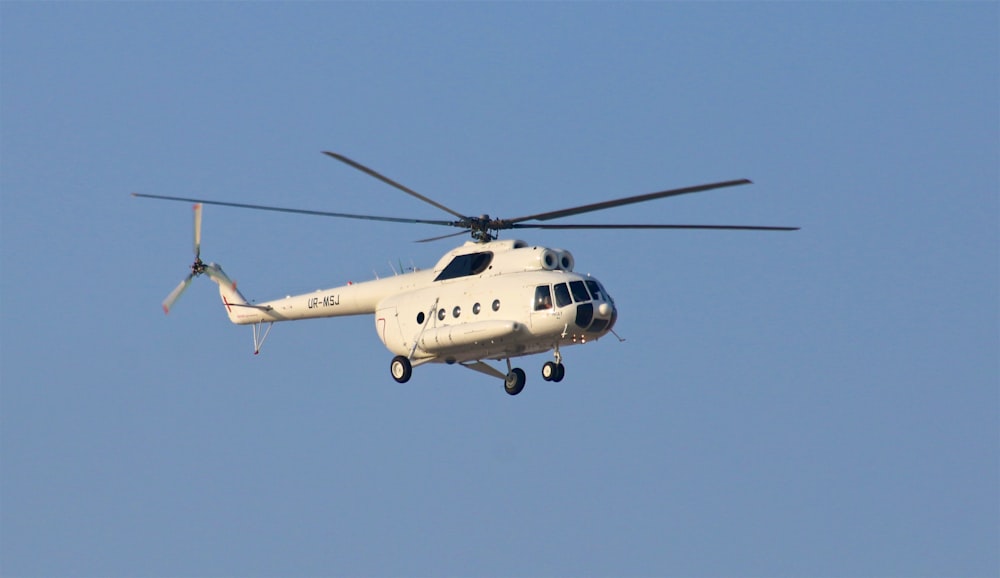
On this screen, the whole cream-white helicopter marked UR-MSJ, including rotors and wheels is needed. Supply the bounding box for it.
[132,151,798,395]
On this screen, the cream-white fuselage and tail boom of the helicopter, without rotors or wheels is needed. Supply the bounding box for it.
[206,241,617,365]
